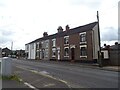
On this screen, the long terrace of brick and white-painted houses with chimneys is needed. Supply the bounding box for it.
[25,22,100,61]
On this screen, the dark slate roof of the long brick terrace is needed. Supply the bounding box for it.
[28,22,98,44]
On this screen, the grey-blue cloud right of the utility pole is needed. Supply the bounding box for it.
[101,27,118,41]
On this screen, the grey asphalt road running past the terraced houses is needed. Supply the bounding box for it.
[13,59,118,88]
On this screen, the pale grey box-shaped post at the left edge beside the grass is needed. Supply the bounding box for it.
[0,57,12,76]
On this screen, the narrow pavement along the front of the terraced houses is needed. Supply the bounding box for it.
[25,59,120,72]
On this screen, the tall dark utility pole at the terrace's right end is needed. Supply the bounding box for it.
[97,11,103,67]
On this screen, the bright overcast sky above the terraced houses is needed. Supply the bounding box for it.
[0,0,119,50]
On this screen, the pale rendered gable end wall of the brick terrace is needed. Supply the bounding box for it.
[92,24,100,59]
